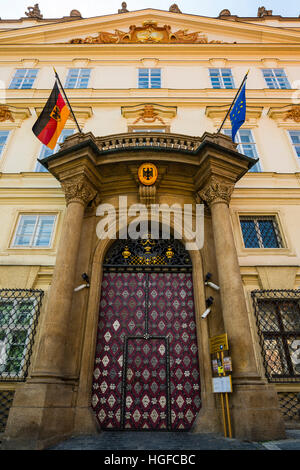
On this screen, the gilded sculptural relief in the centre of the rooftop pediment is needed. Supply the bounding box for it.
[69,20,222,44]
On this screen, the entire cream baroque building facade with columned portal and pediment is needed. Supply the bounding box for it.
[0,2,300,449]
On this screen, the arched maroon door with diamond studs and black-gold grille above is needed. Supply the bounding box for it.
[92,238,201,431]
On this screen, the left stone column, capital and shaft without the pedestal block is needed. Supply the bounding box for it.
[31,175,96,379]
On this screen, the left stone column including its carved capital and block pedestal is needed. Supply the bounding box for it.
[4,171,96,449]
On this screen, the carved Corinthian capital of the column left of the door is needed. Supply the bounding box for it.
[61,175,97,206]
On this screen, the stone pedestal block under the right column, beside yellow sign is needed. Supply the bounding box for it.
[229,381,286,441]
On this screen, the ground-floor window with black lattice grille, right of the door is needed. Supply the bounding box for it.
[251,290,300,383]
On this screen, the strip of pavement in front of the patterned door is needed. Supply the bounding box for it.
[48,430,300,451]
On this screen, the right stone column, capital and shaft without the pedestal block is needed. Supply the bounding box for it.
[200,177,258,378]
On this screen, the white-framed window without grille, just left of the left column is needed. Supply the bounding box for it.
[12,214,56,248]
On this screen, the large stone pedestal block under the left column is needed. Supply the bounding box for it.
[2,379,75,450]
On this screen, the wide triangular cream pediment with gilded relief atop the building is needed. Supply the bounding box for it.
[0,9,300,47]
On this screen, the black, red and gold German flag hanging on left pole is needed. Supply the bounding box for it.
[32,82,70,150]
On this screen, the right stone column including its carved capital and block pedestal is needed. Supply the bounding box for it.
[199,175,284,440]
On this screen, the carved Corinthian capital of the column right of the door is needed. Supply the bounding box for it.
[198,176,234,206]
